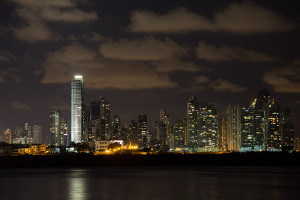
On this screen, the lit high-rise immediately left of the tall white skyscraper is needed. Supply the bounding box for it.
[50,110,67,146]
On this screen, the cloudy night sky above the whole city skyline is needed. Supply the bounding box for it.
[0,0,300,138]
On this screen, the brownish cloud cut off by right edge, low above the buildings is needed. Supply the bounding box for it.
[263,65,300,93]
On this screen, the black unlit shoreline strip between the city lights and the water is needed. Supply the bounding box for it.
[0,153,300,168]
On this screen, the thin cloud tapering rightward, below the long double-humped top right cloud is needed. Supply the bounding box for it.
[196,41,277,62]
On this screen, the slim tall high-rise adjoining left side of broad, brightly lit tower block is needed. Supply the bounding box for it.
[187,97,199,152]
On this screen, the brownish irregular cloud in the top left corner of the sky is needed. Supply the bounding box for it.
[11,0,98,42]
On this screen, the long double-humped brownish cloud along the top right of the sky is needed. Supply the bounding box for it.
[128,1,298,34]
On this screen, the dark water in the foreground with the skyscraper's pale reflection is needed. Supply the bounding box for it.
[0,166,300,200]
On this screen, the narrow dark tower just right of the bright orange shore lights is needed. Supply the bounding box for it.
[138,113,150,148]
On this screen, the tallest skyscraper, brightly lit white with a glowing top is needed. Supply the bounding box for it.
[71,75,83,144]
